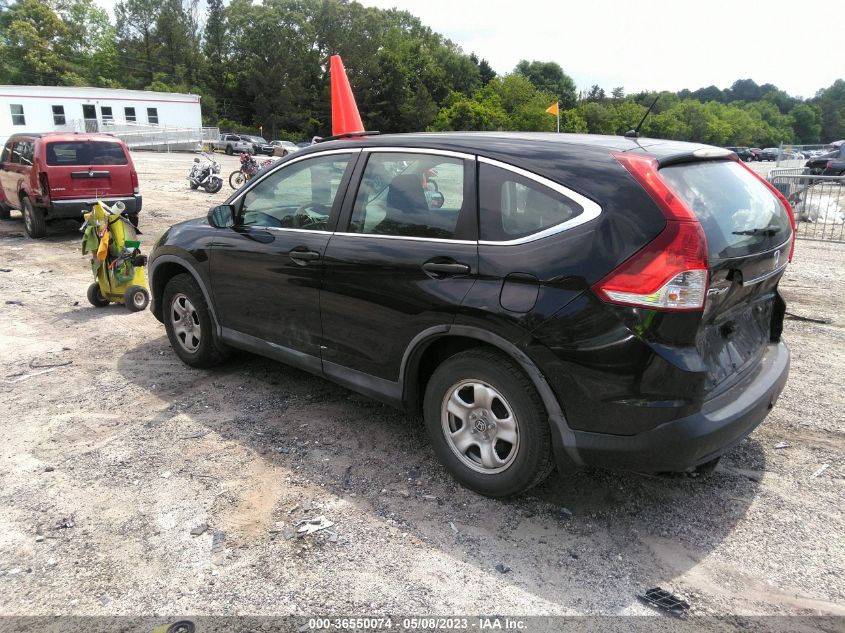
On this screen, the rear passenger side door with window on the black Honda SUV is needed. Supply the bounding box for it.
[320,148,478,382]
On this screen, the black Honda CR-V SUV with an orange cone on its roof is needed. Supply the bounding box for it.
[149,133,794,496]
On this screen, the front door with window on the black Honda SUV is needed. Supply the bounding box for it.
[211,151,357,360]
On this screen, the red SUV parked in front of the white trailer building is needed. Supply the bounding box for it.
[0,134,141,237]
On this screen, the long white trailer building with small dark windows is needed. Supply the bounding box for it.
[0,86,209,149]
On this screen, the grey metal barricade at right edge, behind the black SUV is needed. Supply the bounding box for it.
[768,168,845,244]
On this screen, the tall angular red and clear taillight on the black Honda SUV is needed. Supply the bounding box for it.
[593,152,708,310]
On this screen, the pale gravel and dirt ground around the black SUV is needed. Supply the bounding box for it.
[0,153,845,616]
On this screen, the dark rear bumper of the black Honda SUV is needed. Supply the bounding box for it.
[567,343,789,472]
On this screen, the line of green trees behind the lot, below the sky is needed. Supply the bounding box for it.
[0,0,845,147]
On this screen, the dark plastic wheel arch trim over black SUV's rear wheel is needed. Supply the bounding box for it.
[400,325,583,472]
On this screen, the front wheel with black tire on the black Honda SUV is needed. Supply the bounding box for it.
[162,273,228,367]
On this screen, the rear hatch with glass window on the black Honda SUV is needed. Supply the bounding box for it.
[660,160,792,396]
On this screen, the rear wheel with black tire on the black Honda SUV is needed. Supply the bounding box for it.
[423,349,554,497]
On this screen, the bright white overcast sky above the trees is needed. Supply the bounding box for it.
[92,0,845,98]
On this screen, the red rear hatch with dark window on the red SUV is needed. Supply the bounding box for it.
[45,139,134,200]
